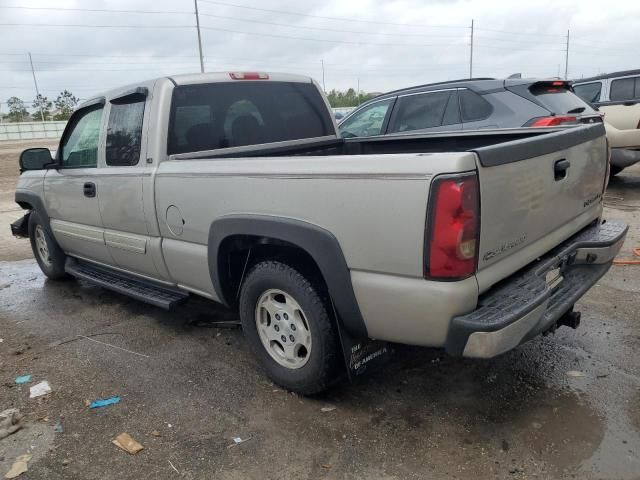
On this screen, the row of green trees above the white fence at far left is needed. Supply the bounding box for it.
[4,90,79,122]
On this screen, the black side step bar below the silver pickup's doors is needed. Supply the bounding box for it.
[64,258,189,310]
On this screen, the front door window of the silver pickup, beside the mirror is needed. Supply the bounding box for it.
[60,105,104,168]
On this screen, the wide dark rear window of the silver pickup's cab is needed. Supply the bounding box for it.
[168,82,335,155]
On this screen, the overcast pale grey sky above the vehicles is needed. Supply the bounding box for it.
[0,0,640,111]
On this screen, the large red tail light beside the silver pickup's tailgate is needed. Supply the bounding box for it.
[425,173,480,280]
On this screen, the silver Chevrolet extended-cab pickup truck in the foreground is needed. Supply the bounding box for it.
[12,73,627,394]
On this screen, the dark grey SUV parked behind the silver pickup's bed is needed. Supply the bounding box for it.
[340,78,602,138]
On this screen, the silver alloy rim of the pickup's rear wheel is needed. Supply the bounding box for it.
[256,289,311,369]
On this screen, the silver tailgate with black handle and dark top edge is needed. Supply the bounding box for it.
[475,124,608,292]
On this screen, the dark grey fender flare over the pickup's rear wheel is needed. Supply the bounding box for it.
[207,214,368,338]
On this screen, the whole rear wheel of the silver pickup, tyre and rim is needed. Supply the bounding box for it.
[240,261,341,395]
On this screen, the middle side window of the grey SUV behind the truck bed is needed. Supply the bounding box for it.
[389,90,460,132]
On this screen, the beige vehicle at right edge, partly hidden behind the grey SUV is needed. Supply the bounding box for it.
[573,70,640,175]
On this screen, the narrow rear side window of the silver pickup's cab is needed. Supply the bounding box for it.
[105,94,146,166]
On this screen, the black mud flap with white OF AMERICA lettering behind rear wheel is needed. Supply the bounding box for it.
[331,302,393,382]
